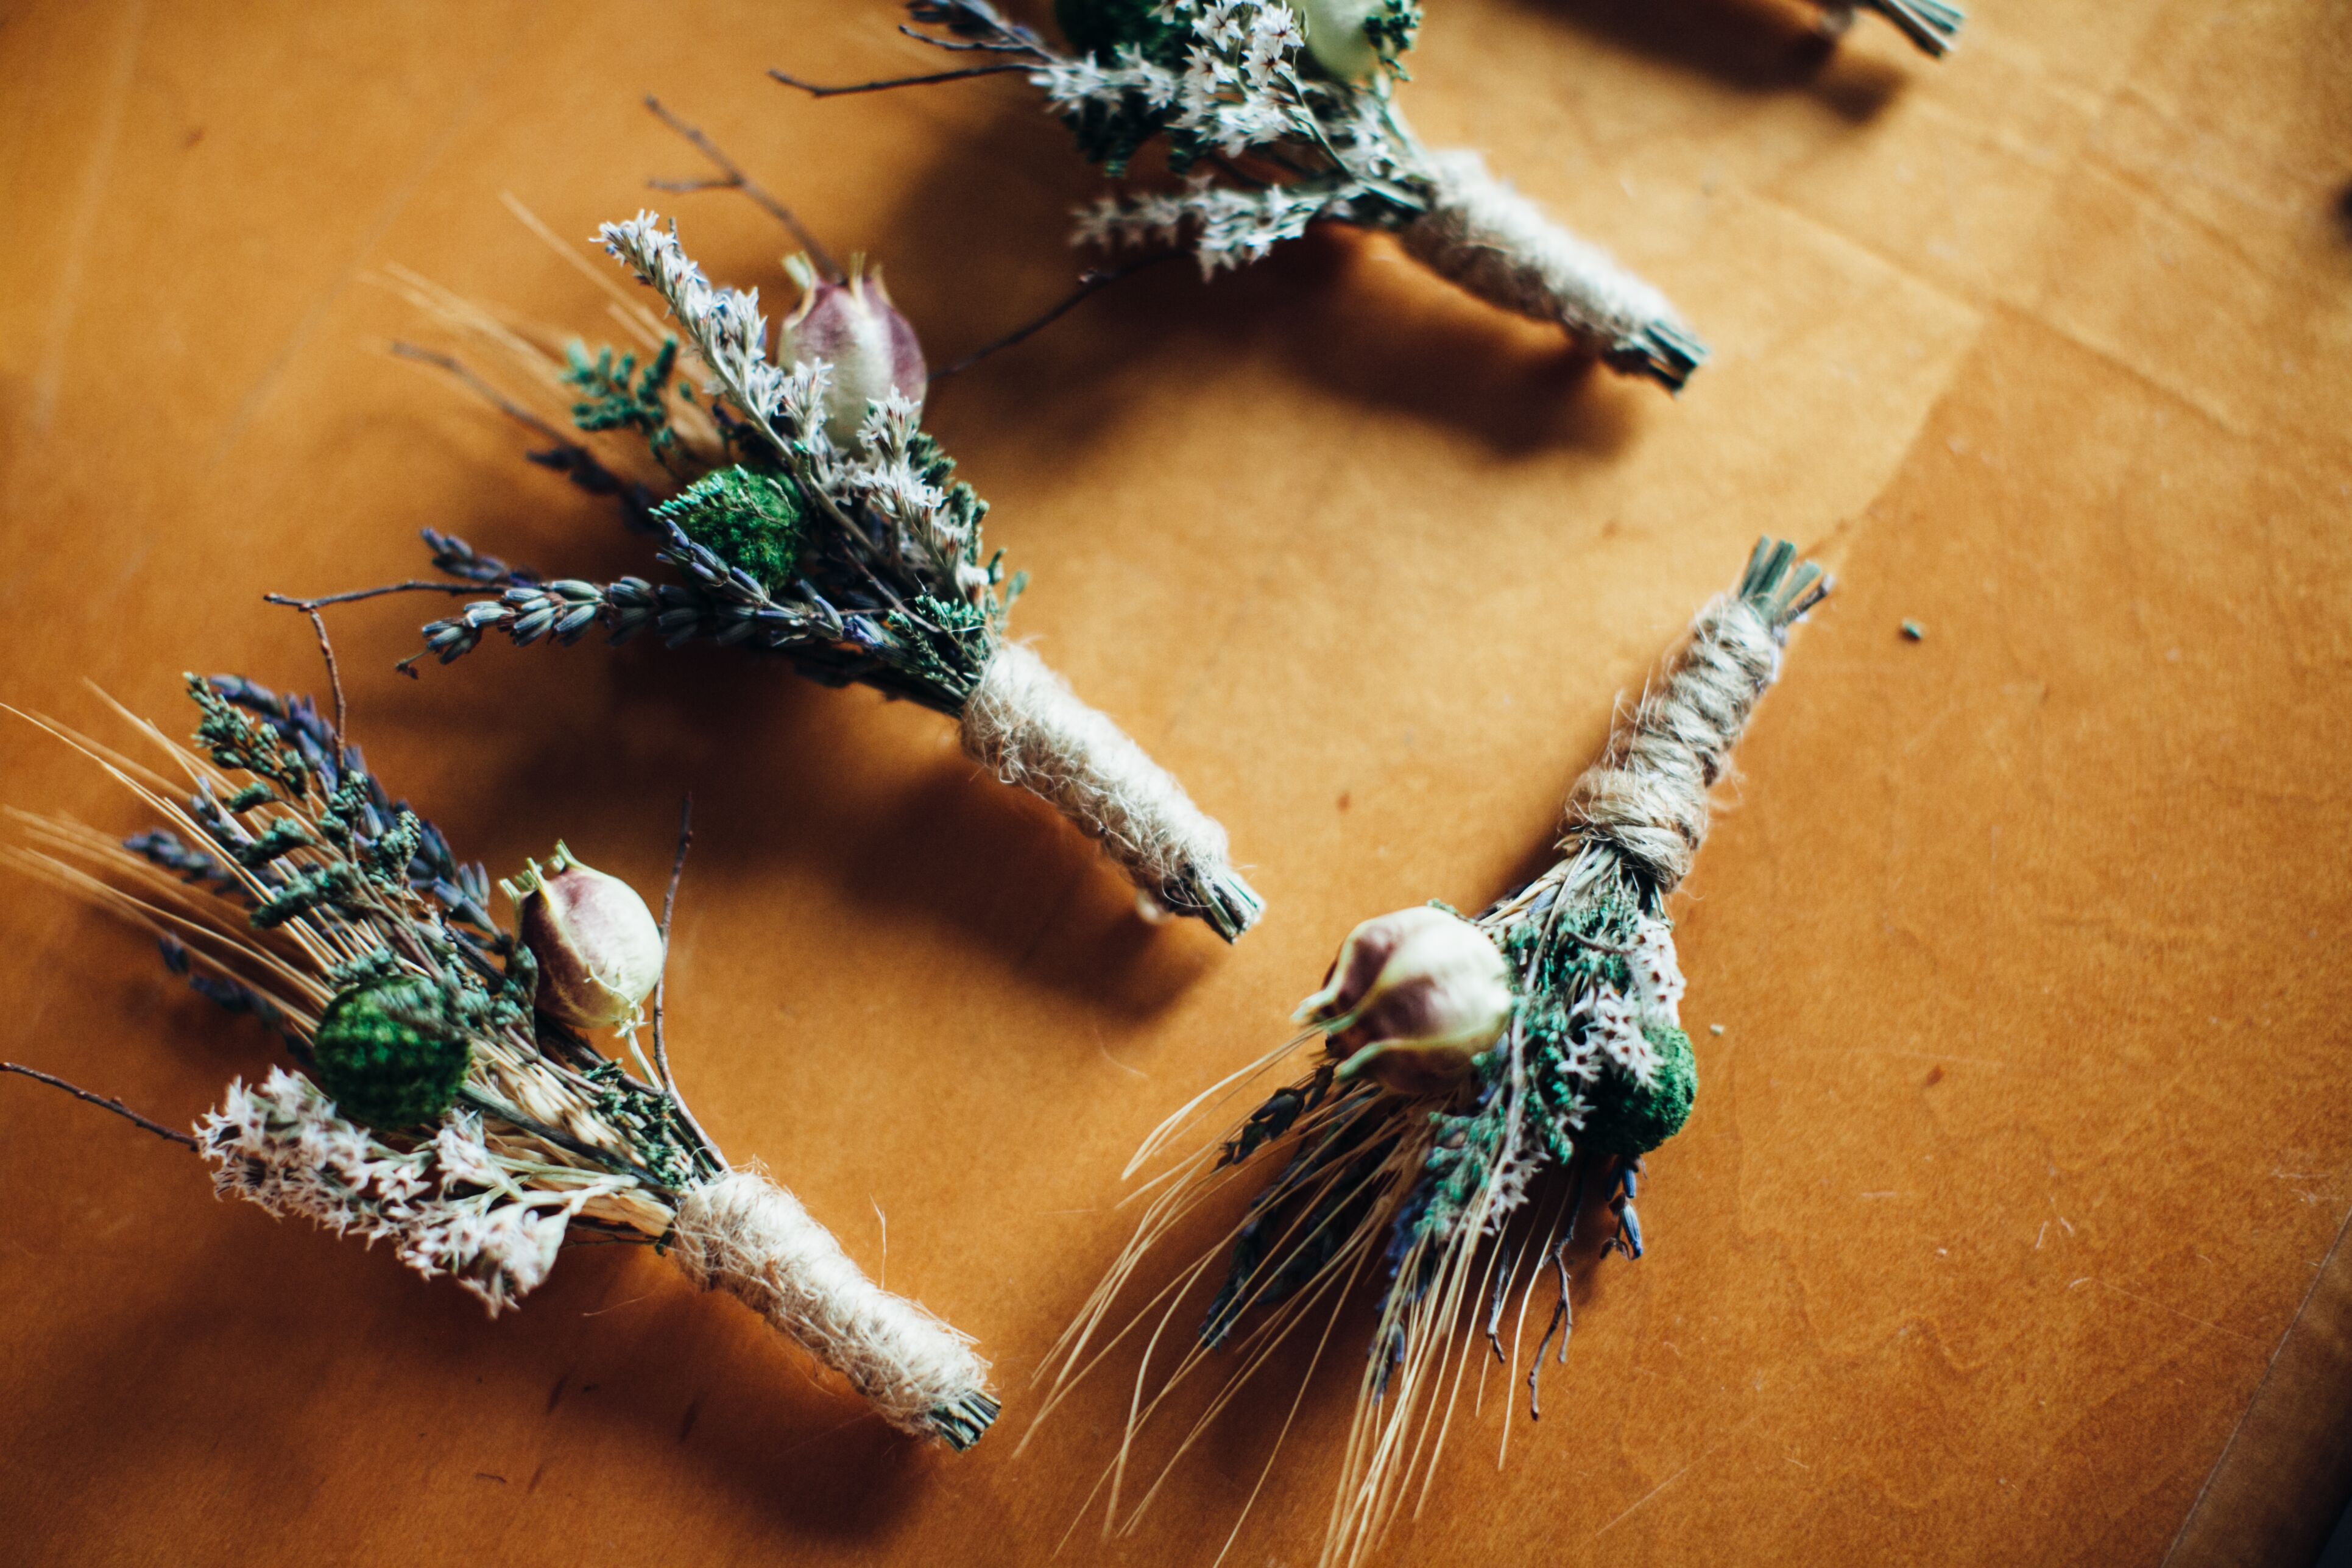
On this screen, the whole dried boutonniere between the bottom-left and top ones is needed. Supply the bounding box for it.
[327,214,1263,941]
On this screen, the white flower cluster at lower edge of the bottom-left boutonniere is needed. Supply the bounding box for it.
[197,1067,593,1316]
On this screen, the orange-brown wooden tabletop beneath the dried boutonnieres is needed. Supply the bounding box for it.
[0,0,2352,1566]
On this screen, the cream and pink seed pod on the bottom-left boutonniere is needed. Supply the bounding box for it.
[499,842,663,1032]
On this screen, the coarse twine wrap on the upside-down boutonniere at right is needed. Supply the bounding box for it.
[1569,595,1781,898]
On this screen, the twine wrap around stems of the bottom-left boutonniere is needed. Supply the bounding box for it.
[670,1166,988,1436]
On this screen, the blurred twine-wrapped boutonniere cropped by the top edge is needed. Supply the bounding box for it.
[774,0,1707,388]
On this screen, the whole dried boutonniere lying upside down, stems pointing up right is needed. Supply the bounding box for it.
[1040,541,1825,1566]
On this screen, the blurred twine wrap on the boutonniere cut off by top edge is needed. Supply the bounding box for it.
[1399,148,1682,343]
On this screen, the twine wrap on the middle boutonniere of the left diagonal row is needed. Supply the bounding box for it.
[962,642,1256,926]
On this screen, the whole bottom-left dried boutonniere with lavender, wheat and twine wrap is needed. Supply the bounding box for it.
[7,675,997,1448]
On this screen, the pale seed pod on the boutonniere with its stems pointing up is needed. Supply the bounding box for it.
[1294,905,1513,1093]
